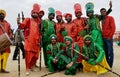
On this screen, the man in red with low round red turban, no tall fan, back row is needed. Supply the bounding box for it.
[63,13,77,42]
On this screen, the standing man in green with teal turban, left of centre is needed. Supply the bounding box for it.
[41,7,55,66]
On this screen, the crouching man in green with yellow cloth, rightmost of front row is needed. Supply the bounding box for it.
[82,35,110,75]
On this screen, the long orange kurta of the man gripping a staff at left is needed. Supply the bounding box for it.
[20,18,40,52]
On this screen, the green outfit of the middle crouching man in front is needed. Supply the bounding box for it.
[60,43,80,75]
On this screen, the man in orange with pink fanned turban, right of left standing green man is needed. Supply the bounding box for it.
[55,10,64,43]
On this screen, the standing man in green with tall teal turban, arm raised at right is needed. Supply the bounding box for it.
[85,2,112,47]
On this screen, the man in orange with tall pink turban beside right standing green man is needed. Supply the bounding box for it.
[73,3,87,63]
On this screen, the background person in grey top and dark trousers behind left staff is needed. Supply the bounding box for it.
[13,28,25,60]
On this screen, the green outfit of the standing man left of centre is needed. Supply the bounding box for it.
[41,19,55,65]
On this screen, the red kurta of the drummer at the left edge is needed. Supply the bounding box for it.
[0,20,12,53]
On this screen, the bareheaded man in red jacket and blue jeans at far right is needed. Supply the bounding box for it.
[100,8,116,68]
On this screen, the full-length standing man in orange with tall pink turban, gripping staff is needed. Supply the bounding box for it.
[17,4,40,75]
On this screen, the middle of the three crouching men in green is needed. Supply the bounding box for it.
[60,36,80,75]
